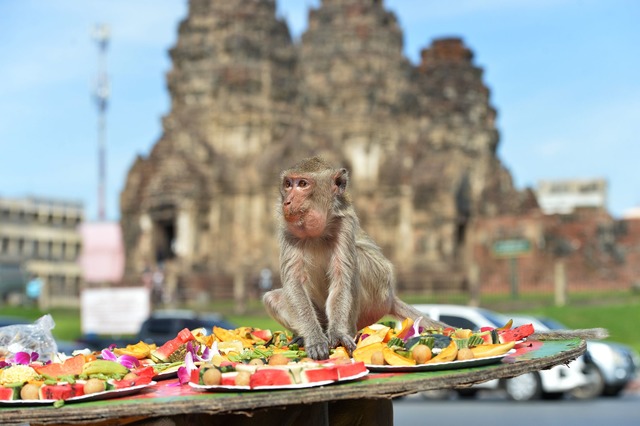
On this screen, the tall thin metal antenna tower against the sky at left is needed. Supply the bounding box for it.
[91,24,110,221]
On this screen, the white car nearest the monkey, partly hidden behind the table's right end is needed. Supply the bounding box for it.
[414,304,589,401]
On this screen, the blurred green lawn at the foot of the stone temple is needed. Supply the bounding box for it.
[0,293,640,352]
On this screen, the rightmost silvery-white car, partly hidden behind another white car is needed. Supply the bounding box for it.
[511,315,638,399]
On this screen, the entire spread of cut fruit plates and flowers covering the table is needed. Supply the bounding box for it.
[0,318,534,406]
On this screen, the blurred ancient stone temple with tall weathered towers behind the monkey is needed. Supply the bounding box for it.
[121,0,527,306]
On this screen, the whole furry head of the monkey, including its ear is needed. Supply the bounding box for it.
[280,157,351,239]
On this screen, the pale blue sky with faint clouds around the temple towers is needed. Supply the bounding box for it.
[0,0,640,220]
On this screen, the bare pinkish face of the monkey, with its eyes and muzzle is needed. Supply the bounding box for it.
[281,175,327,238]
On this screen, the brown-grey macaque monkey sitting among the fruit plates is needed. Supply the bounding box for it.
[263,157,446,359]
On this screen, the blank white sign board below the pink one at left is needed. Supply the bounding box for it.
[80,287,151,335]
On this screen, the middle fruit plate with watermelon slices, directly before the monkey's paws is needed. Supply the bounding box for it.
[114,327,368,391]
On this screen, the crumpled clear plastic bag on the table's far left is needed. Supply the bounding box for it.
[0,314,58,362]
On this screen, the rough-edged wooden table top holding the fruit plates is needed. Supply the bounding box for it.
[0,339,586,426]
